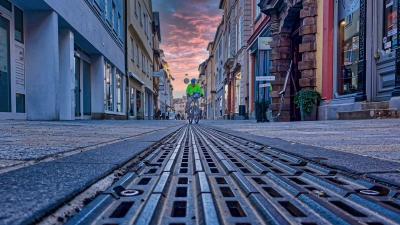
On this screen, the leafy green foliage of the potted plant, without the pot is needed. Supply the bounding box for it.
[294,90,321,120]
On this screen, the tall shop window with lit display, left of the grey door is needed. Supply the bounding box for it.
[337,0,360,95]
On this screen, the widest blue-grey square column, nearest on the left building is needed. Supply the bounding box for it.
[24,11,60,120]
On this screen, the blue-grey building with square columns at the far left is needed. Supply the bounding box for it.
[0,0,126,120]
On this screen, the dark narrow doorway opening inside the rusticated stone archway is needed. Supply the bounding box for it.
[290,19,302,121]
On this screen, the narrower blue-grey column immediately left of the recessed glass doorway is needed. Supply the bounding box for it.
[57,29,75,120]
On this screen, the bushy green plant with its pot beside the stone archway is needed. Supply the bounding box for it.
[294,90,321,121]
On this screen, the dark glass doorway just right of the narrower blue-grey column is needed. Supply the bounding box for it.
[74,52,92,119]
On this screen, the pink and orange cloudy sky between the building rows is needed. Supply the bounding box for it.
[153,0,223,98]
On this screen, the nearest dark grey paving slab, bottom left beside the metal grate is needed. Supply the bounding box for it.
[0,162,116,224]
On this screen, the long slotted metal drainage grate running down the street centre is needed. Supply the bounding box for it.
[68,126,400,225]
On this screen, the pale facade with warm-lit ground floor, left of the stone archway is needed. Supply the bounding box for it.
[219,0,252,119]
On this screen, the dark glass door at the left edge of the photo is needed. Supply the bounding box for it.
[0,16,11,112]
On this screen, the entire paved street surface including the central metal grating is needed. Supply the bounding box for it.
[0,120,400,224]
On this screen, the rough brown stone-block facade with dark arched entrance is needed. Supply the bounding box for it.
[258,0,322,121]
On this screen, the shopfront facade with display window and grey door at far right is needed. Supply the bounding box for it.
[319,0,400,120]
